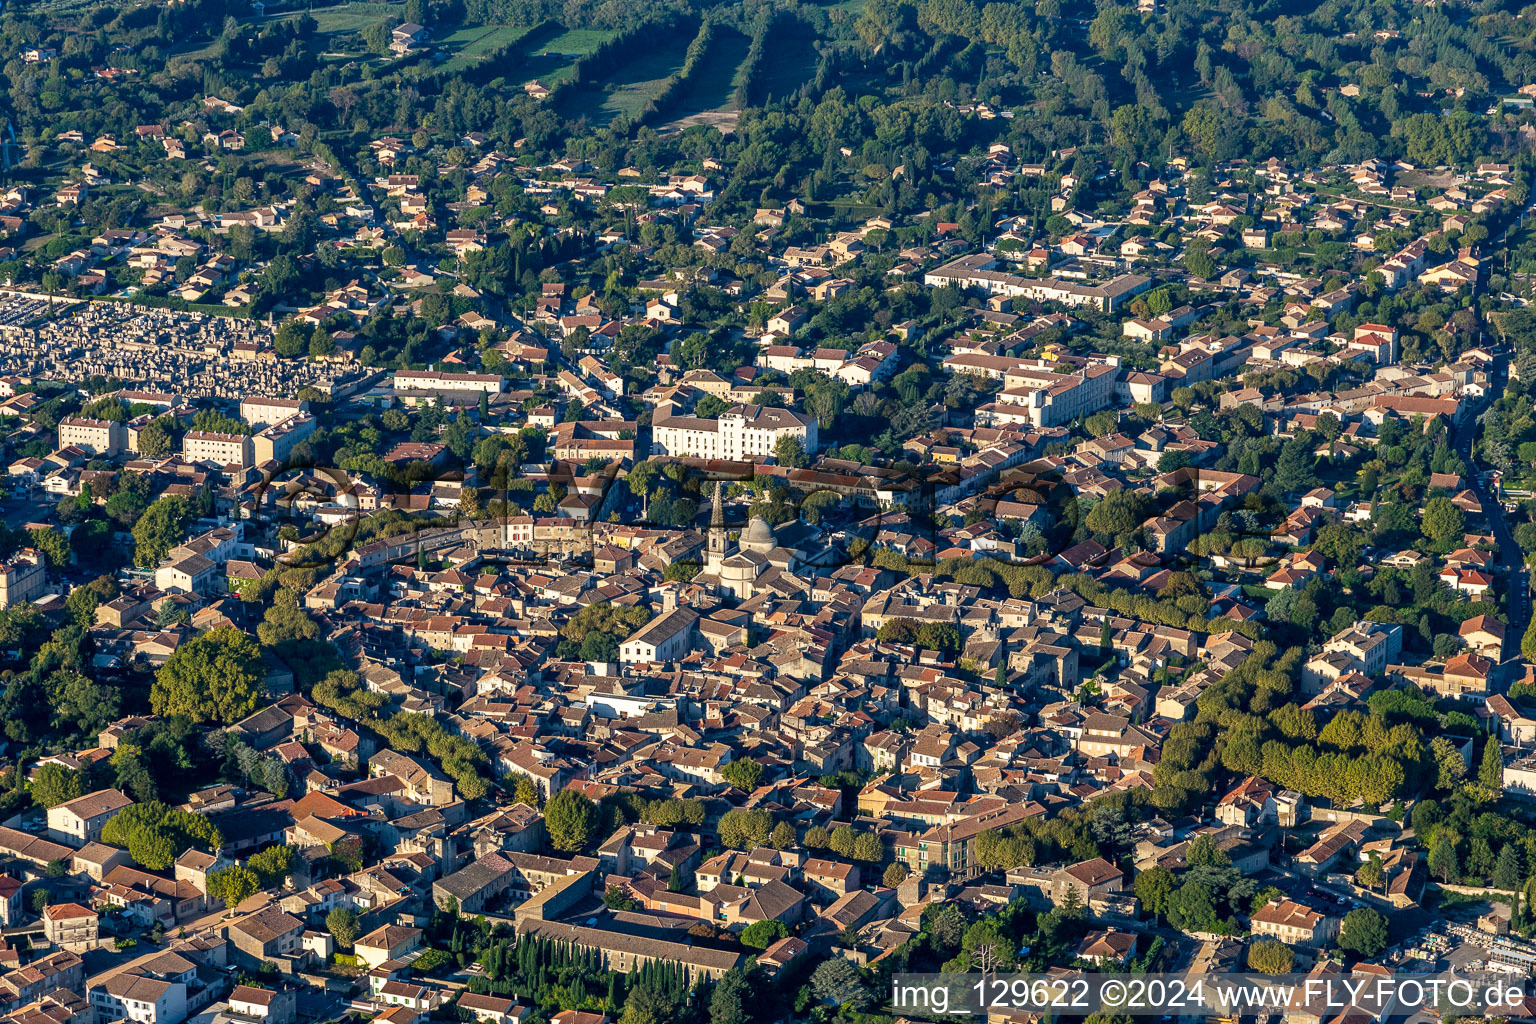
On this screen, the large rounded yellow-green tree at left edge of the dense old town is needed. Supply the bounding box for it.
[149,626,263,725]
